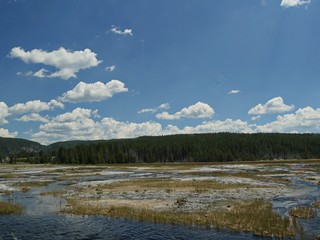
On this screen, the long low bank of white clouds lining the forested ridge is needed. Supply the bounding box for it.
[26,103,320,144]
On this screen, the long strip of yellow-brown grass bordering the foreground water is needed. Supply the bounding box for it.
[64,200,294,237]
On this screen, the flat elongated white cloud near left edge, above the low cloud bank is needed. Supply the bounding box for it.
[8,100,64,114]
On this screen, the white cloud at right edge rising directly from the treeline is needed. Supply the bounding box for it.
[257,107,320,133]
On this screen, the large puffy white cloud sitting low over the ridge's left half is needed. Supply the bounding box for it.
[32,108,161,144]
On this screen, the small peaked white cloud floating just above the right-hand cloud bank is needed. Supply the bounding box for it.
[248,97,294,114]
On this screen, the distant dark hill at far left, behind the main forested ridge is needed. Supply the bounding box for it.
[0,137,45,157]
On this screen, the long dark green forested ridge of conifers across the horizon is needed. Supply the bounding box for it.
[3,133,320,164]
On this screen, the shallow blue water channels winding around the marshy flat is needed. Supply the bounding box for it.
[0,163,320,240]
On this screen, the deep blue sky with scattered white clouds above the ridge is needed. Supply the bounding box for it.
[0,0,320,144]
